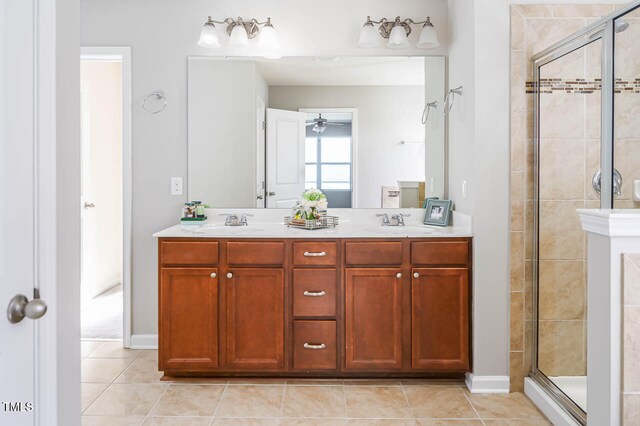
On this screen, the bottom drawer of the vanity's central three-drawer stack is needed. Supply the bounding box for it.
[293,321,337,370]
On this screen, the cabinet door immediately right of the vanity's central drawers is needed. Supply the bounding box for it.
[345,268,403,370]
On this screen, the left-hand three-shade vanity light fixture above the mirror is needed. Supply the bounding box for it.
[198,16,278,50]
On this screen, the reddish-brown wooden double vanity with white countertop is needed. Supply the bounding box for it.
[156,213,471,377]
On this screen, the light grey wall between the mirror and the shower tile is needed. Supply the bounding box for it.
[448,0,616,375]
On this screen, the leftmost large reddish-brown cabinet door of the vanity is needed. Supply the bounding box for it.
[158,268,218,371]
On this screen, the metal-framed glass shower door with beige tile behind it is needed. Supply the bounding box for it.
[533,30,602,418]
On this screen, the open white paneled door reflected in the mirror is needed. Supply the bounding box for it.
[267,108,306,208]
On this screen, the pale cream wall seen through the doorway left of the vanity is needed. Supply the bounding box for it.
[80,61,122,300]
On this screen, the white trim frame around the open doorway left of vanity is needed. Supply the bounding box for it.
[80,46,133,348]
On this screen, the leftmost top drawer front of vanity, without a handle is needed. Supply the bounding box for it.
[160,241,218,265]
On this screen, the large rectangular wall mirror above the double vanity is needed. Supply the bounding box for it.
[188,57,446,208]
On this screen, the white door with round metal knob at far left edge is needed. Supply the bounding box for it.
[0,0,57,426]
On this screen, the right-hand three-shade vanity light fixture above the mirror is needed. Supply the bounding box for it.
[358,16,440,49]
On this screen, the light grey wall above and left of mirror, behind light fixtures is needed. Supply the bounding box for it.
[80,0,447,334]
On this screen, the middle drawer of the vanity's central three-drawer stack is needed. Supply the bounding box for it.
[293,269,337,317]
